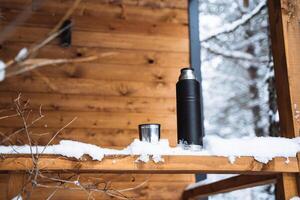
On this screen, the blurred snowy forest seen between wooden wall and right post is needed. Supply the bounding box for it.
[199,0,279,200]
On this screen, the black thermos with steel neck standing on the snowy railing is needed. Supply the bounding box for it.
[176,68,203,146]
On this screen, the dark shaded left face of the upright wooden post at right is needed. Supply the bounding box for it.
[268,0,295,137]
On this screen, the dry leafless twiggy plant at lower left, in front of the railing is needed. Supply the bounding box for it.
[2,95,145,200]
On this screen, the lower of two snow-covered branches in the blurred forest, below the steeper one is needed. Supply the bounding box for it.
[201,42,269,63]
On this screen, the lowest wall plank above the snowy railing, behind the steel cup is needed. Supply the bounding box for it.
[0,127,177,149]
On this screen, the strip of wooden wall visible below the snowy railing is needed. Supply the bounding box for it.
[0,172,194,200]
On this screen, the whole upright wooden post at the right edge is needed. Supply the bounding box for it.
[268,0,300,200]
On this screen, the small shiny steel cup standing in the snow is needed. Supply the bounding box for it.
[139,124,160,143]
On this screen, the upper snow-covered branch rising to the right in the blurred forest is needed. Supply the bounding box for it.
[200,0,267,42]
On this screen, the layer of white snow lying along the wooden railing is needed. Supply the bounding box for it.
[0,136,300,164]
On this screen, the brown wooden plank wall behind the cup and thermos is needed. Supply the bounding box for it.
[0,0,194,199]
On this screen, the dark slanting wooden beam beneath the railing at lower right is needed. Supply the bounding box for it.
[182,175,276,200]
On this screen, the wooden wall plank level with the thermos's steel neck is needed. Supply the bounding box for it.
[24,63,179,82]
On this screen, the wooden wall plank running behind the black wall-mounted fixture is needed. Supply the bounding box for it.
[0,25,189,52]
